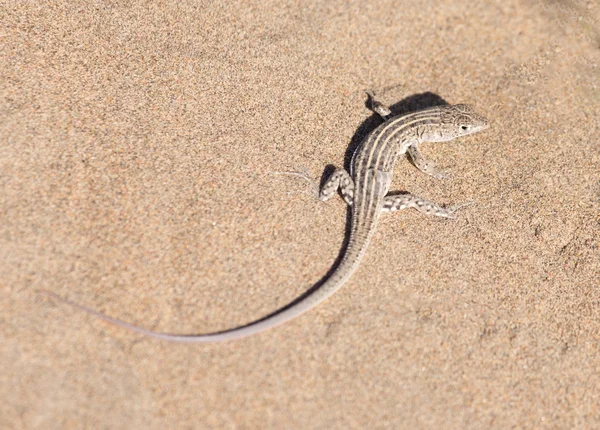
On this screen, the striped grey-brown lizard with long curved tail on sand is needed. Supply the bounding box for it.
[42,91,488,343]
